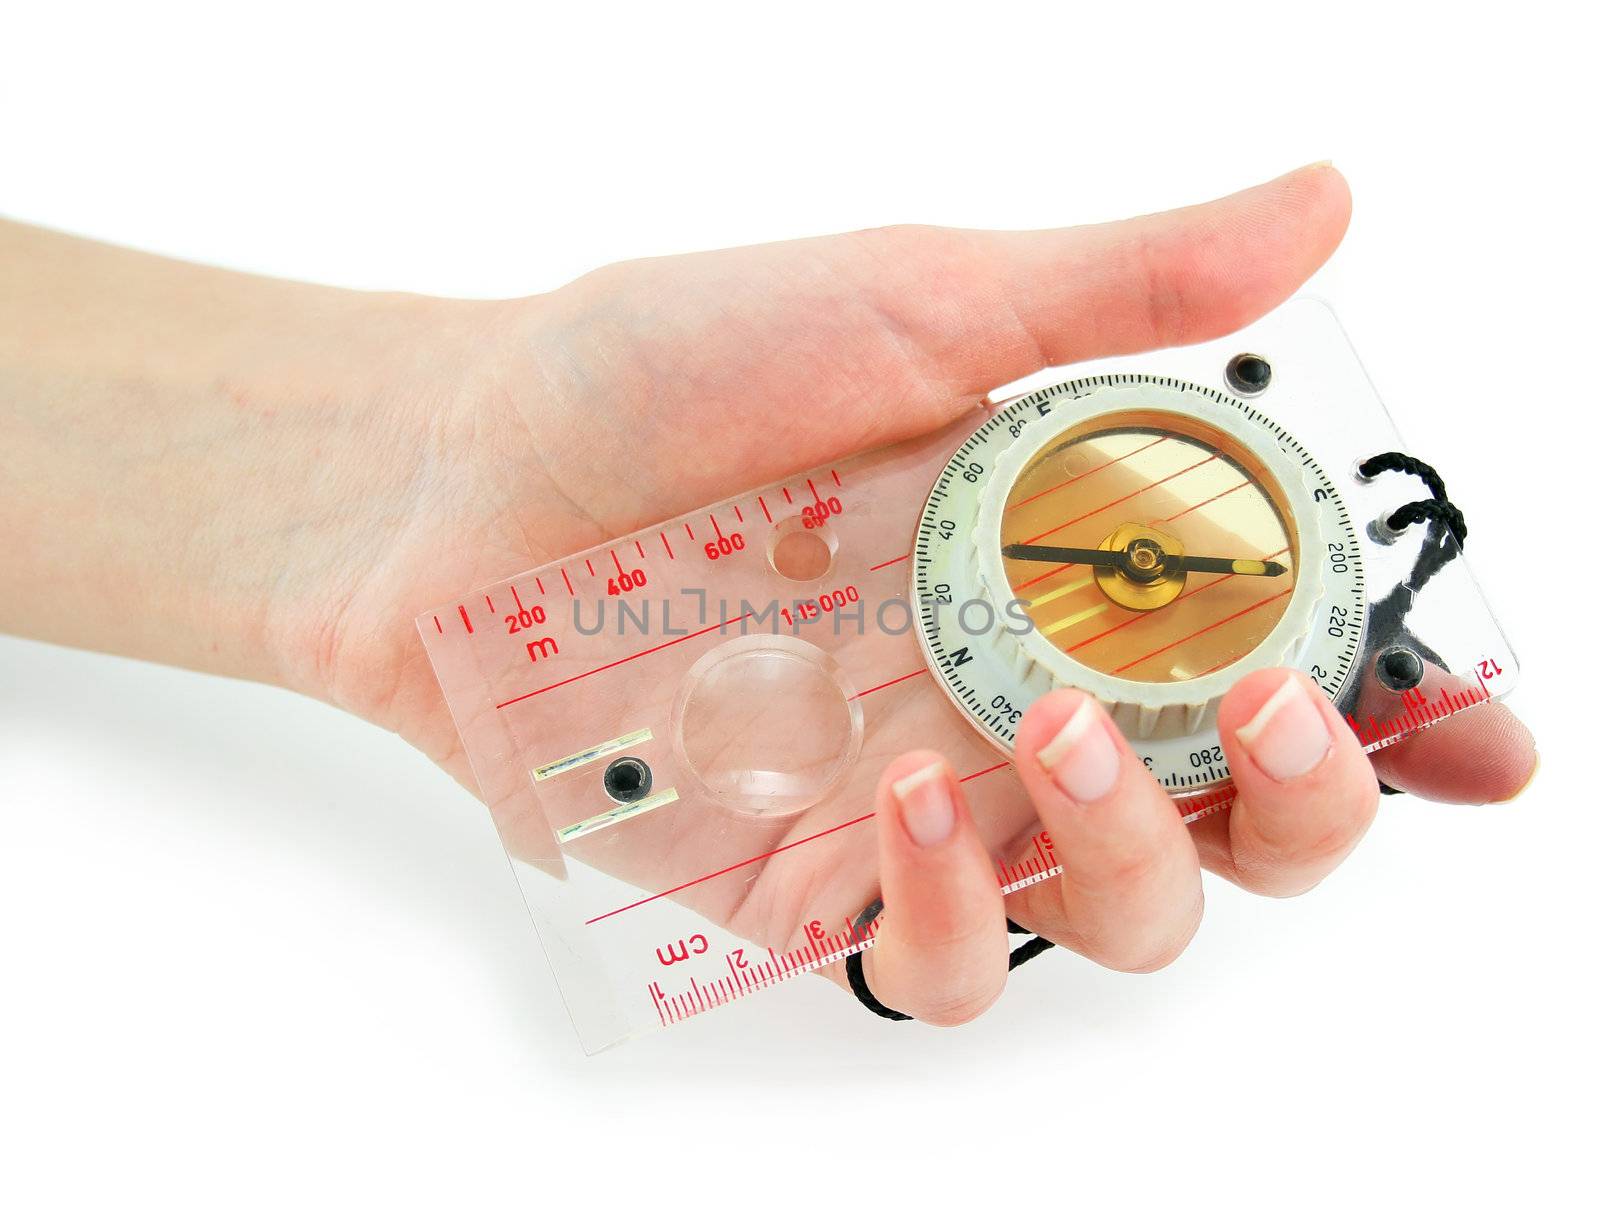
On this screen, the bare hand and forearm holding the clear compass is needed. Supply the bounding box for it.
[0,166,1533,1022]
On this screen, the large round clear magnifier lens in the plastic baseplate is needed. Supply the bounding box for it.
[674,634,861,816]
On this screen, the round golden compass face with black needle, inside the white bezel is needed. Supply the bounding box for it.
[1000,410,1301,683]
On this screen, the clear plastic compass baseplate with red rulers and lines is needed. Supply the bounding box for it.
[418,299,1517,1051]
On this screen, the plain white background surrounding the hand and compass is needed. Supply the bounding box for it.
[0,0,1600,1221]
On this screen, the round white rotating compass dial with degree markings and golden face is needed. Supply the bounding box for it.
[910,374,1366,794]
